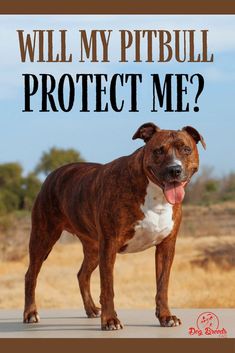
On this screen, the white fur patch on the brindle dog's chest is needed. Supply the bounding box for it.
[123,181,174,253]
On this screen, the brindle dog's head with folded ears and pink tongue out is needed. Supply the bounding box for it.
[132,123,206,204]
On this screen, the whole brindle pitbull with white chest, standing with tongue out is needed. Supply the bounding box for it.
[24,123,206,330]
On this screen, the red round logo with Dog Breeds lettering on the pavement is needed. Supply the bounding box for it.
[188,311,227,338]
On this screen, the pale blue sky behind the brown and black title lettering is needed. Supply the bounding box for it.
[0,15,235,175]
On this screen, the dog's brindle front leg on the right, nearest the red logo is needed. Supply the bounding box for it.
[155,236,181,327]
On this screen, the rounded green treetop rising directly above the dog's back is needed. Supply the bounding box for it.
[35,147,84,175]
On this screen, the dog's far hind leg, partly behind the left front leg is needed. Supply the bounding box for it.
[77,242,101,318]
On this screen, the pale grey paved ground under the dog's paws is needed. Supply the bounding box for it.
[0,309,235,338]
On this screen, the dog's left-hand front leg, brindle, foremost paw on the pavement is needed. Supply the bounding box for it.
[99,238,122,330]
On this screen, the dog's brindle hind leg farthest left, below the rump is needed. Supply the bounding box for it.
[23,225,62,323]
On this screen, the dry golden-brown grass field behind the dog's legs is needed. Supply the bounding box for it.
[0,203,235,308]
